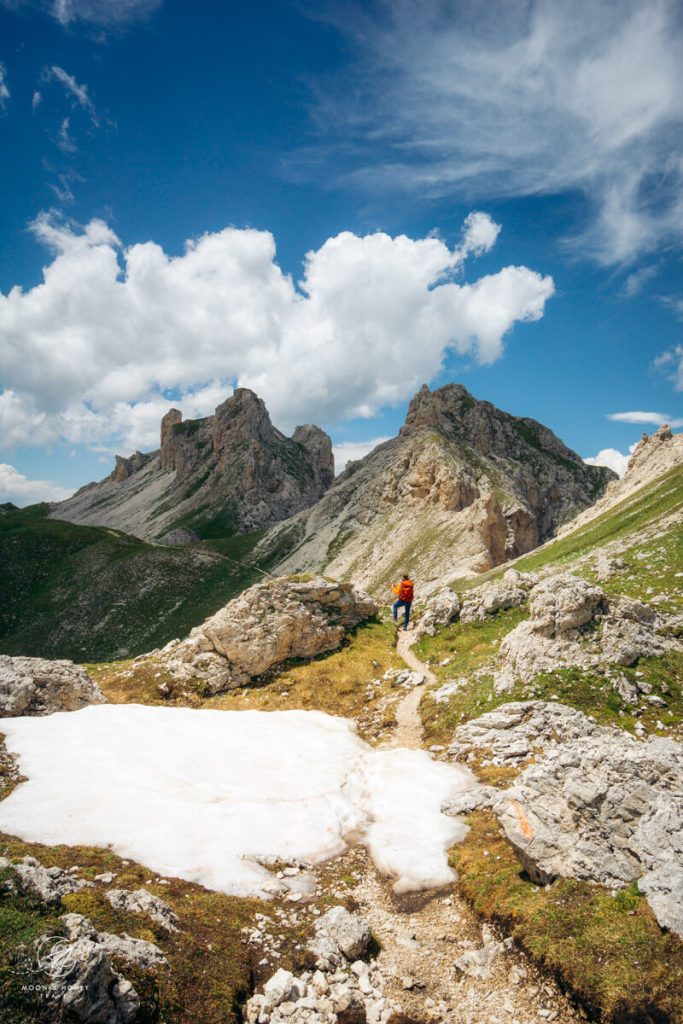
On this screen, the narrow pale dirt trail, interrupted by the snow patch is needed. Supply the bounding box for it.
[333,631,582,1024]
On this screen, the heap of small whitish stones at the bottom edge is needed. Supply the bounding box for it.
[245,961,398,1024]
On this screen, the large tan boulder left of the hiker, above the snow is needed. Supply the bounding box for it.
[160,578,377,693]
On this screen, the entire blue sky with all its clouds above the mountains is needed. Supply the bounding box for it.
[0,0,683,505]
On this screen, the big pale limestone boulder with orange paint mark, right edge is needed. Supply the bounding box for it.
[496,728,683,935]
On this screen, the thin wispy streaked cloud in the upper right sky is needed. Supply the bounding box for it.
[303,0,683,264]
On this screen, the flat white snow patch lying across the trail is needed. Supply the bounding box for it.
[0,705,474,897]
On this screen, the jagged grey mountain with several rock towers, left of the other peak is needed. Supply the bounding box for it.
[51,388,334,543]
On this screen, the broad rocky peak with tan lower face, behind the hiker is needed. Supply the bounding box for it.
[258,384,614,593]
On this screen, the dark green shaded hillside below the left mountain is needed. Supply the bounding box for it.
[0,506,290,662]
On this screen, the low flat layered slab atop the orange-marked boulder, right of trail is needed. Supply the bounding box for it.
[449,700,599,764]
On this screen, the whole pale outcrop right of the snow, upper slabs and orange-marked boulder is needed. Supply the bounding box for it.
[444,700,683,936]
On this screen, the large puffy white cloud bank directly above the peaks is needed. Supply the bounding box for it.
[0,214,554,446]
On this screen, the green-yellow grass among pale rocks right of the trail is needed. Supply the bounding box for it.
[418,469,683,1024]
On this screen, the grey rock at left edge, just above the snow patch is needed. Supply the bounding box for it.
[0,654,104,718]
